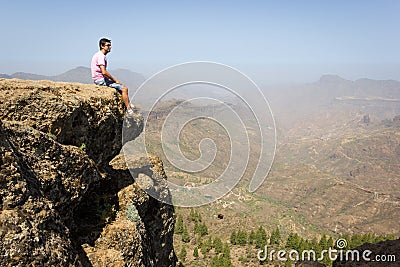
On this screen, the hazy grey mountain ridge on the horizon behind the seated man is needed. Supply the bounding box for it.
[0,67,145,91]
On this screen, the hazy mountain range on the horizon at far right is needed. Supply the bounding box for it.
[264,75,400,127]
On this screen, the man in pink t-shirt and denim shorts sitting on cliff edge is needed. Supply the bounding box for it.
[90,38,134,114]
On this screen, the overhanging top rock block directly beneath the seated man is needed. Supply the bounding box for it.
[0,79,143,167]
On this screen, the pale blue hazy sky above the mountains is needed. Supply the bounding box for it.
[0,0,400,83]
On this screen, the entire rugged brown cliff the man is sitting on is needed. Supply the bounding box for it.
[0,79,176,266]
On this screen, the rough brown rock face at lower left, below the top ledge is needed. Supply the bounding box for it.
[0,123,97,266]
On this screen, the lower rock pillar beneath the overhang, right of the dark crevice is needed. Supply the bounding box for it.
[79,155,176,267]
